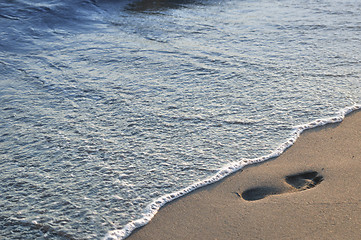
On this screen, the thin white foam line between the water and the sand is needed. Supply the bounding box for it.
[104,104,361,240]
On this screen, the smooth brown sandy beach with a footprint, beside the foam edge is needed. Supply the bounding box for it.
[127,111,361,240]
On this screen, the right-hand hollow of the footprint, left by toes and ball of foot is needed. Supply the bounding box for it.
[286,171,323,191]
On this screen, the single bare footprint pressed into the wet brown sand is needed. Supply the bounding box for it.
[238,171,323,201]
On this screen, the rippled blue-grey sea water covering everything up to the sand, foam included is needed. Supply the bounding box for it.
[0,0,361,239]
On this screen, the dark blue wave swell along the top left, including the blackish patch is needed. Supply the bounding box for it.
[0,0,200,51]
